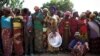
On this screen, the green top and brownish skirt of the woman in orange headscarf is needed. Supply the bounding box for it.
[32,12,44,52]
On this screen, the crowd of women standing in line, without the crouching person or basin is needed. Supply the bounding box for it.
[0,6,100,56]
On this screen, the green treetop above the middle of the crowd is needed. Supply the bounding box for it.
[42,0,73,11]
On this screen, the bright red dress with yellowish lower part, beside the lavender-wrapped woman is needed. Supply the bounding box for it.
[79,19,88,41]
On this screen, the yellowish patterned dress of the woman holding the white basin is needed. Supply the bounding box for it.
[47,19,59,52]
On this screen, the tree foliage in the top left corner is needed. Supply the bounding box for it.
[0,0,24,9]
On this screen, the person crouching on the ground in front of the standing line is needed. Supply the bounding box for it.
[69,32,89,56]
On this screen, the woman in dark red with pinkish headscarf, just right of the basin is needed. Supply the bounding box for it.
[59,11,71,51]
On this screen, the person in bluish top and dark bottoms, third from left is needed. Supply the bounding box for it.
[21,8,33,56]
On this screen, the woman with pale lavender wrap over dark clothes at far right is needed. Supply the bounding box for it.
[88,14,100,53]
